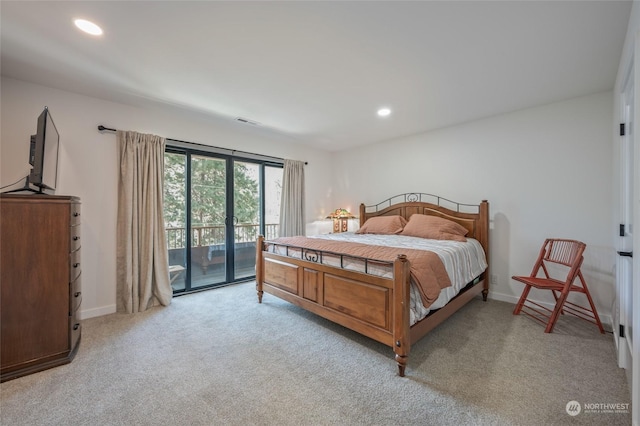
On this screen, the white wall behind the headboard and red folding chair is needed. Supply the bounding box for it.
[333,92,615,319]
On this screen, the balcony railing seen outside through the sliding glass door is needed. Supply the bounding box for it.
[166,223,279,250]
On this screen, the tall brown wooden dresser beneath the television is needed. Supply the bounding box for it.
[0,194,82,382]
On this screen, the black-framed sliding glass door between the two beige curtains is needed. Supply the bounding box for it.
[164,149,282,294]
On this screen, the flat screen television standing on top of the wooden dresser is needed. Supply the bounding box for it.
[28,107,60,192]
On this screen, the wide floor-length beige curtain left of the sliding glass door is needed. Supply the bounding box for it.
[116,130,173,313]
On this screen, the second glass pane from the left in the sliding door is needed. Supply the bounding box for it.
[190,155,227,289]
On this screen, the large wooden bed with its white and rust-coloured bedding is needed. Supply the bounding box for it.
[256,193,490,376]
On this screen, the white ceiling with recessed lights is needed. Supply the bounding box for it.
[0,0,631,151]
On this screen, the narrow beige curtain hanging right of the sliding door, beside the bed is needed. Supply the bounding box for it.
[280,160,305,237]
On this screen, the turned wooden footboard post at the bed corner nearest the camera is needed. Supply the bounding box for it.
[392,254,411,377]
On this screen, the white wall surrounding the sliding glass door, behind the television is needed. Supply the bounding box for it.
[0,78,333,318]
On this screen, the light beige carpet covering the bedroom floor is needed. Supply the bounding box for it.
[0,283,631,426]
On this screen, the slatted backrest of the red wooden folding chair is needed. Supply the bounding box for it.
[531,238,587,283]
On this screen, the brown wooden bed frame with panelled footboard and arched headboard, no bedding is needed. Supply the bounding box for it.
[256,193,490,376]
